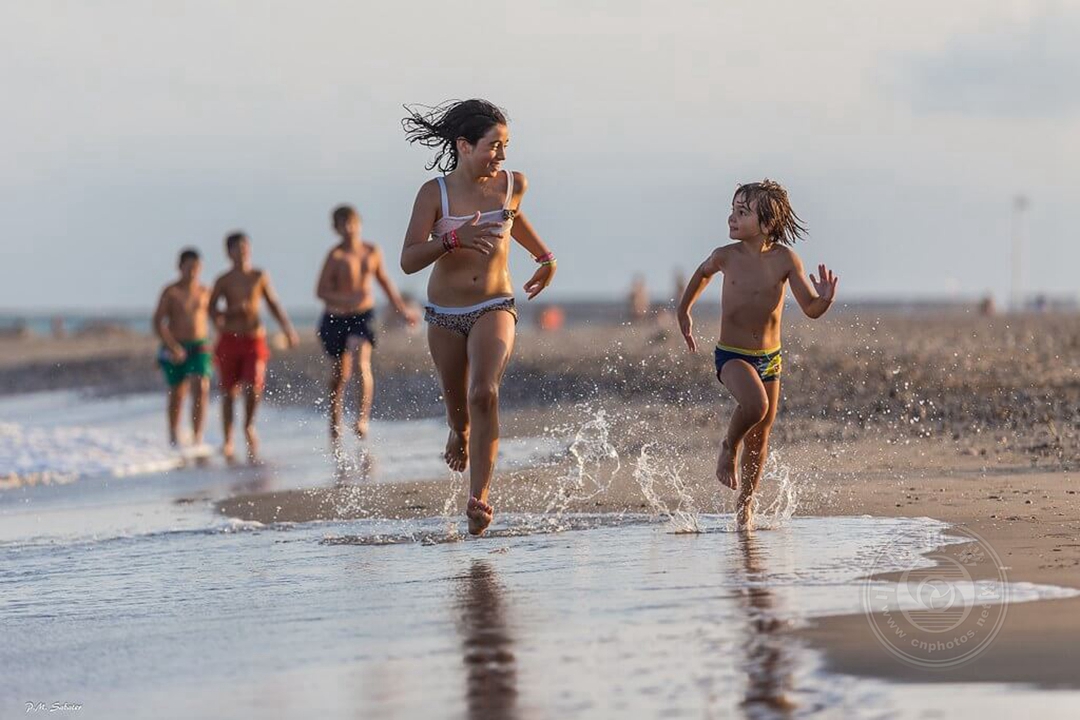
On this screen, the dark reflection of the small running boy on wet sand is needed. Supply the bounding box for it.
[739,532,796,718]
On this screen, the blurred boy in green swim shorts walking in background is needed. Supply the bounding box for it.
[153,247,213,448]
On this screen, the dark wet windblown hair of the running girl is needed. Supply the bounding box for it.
[402,99,507,173]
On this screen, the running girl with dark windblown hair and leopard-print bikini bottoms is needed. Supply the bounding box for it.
[401,99,555,535]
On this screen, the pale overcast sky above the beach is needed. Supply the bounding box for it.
[0,0,1080,309]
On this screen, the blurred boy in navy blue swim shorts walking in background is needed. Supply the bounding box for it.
[315,205,419,451]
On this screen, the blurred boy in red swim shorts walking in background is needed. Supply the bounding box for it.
[210,232,299,463]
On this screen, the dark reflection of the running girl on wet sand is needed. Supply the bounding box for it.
[457,560,517,720]
